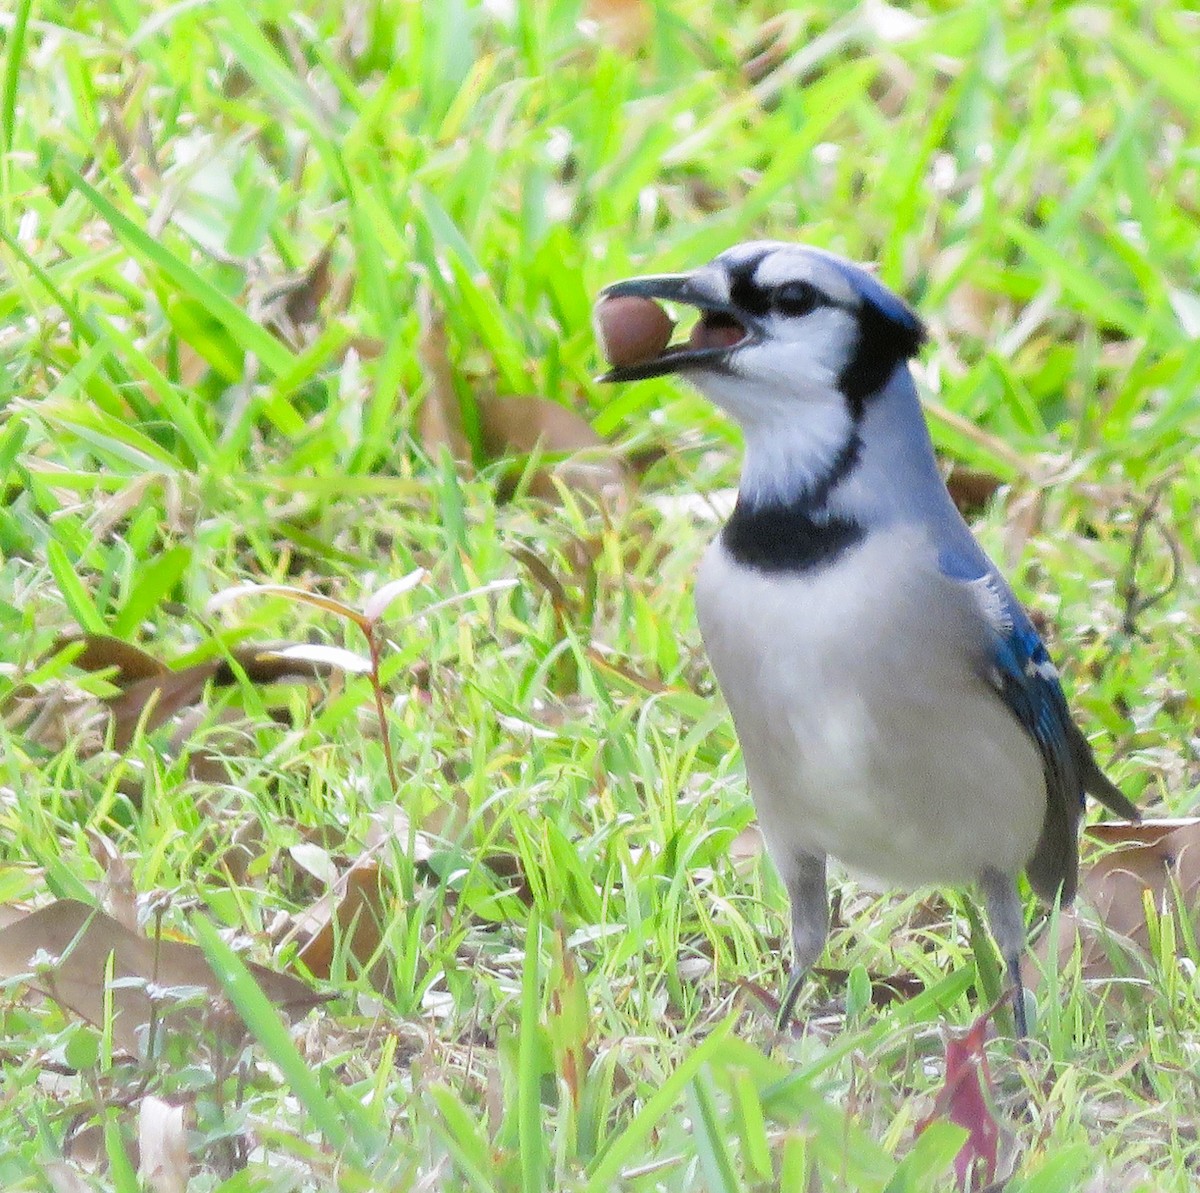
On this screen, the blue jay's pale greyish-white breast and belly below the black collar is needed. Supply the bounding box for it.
[696,533,1045,887]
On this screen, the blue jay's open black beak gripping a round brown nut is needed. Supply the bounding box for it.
[596,274,752,382]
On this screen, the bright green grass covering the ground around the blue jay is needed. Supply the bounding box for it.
[0,0,1200,1193]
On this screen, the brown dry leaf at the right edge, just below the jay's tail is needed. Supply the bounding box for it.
[1028,817,1200,984]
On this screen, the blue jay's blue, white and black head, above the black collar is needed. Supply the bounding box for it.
[604,241,936,516]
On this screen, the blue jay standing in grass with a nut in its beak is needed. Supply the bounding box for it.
[598,241,1138,1038]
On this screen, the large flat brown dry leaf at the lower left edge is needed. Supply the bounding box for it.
[0,899,328,1056]
